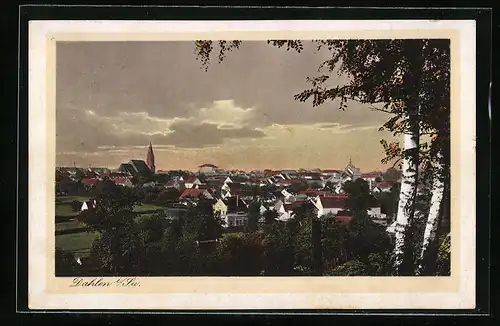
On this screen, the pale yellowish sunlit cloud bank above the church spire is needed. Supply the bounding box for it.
[56,101,265,152]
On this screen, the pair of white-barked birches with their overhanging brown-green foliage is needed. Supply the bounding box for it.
[195,39,450,275]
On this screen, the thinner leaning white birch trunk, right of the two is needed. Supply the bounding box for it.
[419,153,444,270]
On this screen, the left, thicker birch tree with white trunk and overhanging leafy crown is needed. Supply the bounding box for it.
[196,39,450,275]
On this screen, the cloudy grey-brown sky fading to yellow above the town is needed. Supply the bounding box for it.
[56,41,398,171]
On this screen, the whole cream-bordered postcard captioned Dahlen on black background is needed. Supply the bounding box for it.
[28,20,476,310]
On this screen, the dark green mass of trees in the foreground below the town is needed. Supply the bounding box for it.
[56,180,449,276]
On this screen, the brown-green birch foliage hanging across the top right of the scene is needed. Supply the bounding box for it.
[196,39,450,168]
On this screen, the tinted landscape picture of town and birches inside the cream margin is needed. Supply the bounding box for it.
[54,39,450,277]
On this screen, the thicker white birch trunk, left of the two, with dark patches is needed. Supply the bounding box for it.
[394,116,420,275]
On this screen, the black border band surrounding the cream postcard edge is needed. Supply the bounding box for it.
[15,5,492,317]
